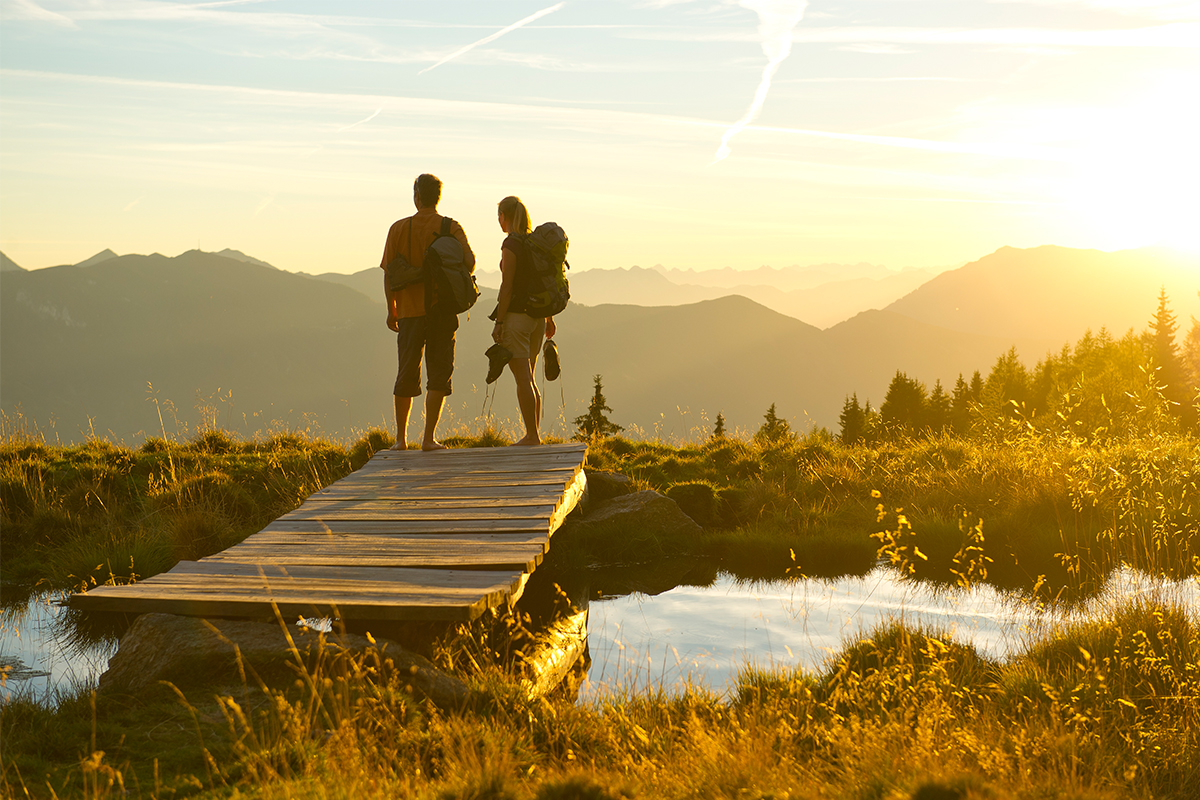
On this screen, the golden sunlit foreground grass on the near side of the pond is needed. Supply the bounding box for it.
[0,599,1200,799]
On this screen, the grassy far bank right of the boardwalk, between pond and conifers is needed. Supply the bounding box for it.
[564,433,1200,600]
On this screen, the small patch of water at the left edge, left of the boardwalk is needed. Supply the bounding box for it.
[0,591,116,705]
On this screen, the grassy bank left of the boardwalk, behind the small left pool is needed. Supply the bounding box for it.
[0,431,391,602]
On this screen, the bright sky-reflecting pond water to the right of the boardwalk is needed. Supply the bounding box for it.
[580,567,1200,702]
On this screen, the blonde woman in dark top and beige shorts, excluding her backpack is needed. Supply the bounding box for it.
[492,197,554,445]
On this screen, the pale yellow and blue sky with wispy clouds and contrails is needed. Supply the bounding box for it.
[0,0,1200,273]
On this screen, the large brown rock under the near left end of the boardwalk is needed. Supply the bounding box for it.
[100,614,470,708]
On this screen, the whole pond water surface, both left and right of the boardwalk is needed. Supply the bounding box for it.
[0,567,1200,705]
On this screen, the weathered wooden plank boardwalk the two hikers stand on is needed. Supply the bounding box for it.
[71,444,587,620]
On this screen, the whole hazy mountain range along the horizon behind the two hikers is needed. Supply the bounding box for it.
[0,247,1200,441]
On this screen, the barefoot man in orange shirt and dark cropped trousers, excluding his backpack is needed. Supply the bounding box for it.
[379,174,475,450]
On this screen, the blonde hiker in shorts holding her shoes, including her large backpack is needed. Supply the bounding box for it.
[491,197,570,445]
